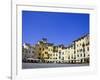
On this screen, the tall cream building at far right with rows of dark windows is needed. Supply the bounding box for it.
[74,34,90,63]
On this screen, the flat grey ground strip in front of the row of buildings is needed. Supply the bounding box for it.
[22,63,89,69]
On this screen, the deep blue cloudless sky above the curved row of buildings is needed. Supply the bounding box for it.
[22,11,89,45]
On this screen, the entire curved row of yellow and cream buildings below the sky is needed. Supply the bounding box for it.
[22,34,90,63]
